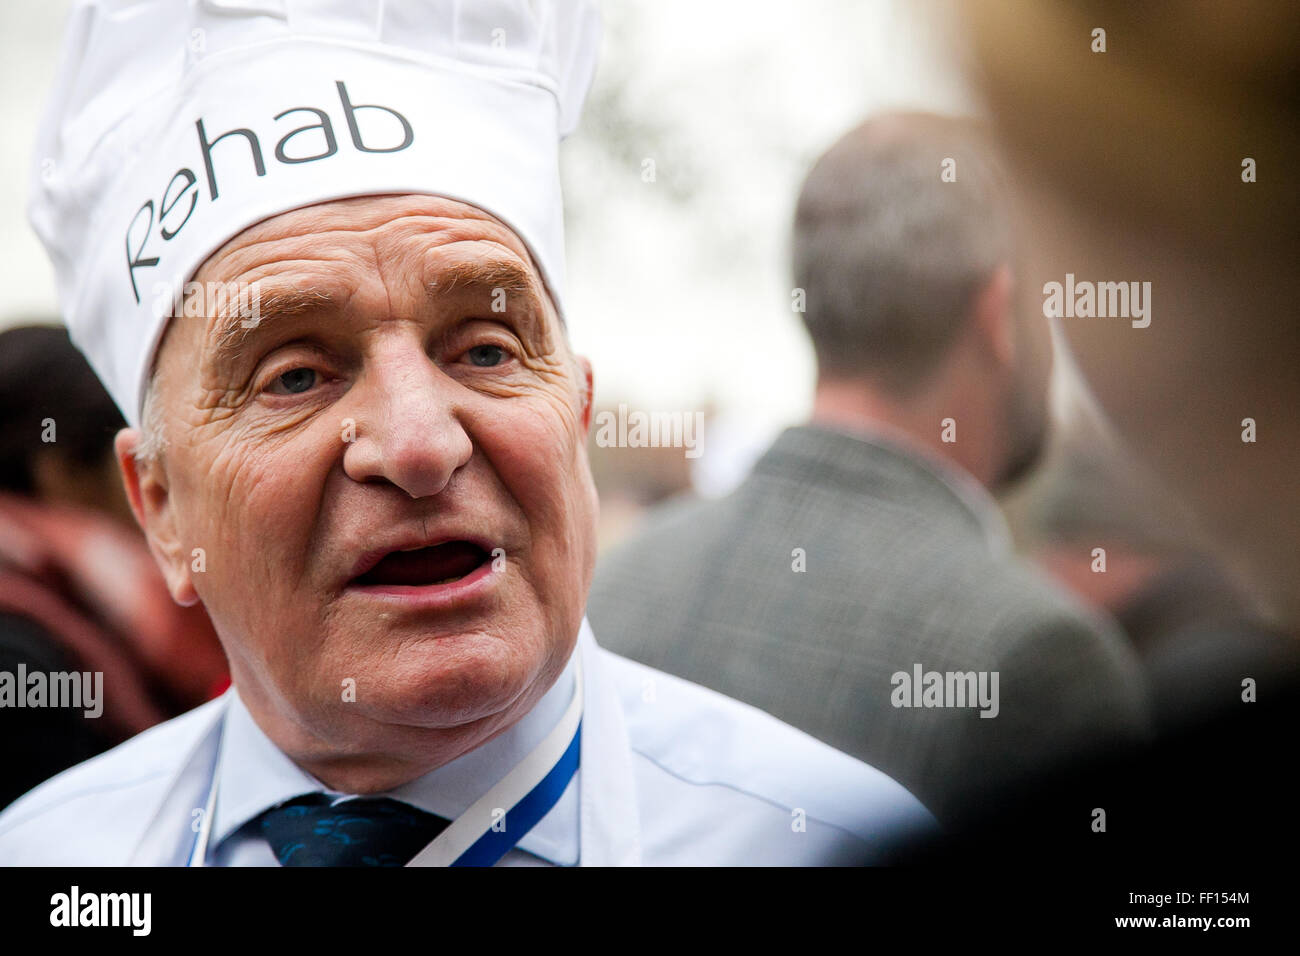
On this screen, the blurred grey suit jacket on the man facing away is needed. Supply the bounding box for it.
[588,427,1148,825]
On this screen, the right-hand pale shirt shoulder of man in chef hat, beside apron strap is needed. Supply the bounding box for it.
[601,649,933,840]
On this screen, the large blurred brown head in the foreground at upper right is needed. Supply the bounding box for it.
[967,0,1300,624]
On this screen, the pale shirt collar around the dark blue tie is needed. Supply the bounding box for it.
[212,642,585,866]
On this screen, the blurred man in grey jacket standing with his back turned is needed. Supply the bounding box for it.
[589,114,1147,821]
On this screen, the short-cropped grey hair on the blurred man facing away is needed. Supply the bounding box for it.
[792,113,1011,393]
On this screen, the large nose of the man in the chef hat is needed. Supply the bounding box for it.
[343,342,473,498]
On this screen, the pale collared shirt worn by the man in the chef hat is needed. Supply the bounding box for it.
[0,620,935,866]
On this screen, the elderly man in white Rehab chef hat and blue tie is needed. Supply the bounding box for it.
[0,3,931,865]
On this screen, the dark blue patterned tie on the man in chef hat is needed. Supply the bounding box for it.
[259,793,450,866]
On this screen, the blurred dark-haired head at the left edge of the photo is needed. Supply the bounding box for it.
[0,325,134,524]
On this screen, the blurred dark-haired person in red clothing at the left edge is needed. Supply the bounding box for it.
[0,324,229,804]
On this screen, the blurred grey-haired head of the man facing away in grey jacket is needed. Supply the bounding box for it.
[793,113,1052,486]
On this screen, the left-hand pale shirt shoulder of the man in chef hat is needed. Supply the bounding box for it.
[0,698,222,865]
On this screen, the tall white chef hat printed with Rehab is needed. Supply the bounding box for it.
[29,0,599,424]
